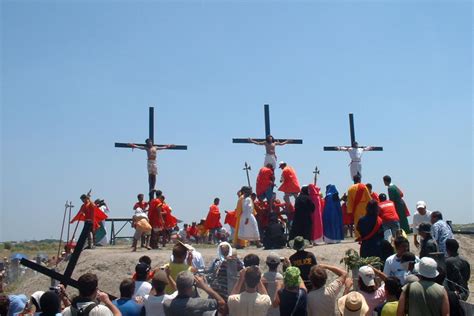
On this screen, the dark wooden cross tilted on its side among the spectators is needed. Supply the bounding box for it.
[20,222,115,299]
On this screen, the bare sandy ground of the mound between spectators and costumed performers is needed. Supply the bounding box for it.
[10,235,474,303]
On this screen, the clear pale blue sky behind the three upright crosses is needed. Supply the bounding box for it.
[0,1,474,241]
